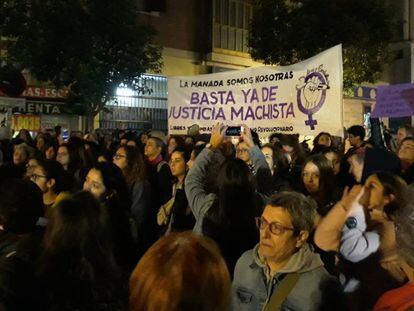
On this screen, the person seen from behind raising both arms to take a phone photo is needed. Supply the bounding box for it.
[185,124,268,274]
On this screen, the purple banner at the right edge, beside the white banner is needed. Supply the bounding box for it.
[372,83,414,118]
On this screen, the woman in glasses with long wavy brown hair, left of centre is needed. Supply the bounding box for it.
[113,145,151,251]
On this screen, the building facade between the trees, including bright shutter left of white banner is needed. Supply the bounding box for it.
[99,0,262,131]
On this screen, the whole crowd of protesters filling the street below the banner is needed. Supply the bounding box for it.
[0,124,414,311]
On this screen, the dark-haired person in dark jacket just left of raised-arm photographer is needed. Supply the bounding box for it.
[157,147,195,233]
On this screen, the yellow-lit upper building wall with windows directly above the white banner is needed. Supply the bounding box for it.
[140,0,262,76]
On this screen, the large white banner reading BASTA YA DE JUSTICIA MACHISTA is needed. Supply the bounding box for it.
[168,45,343,138]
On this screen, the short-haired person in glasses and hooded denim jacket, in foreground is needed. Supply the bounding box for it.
[233,192,337,311]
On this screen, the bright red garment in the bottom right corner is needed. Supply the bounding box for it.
[373,282,414,311]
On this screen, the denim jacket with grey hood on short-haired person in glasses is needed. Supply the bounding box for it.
[232,244,338,311]
